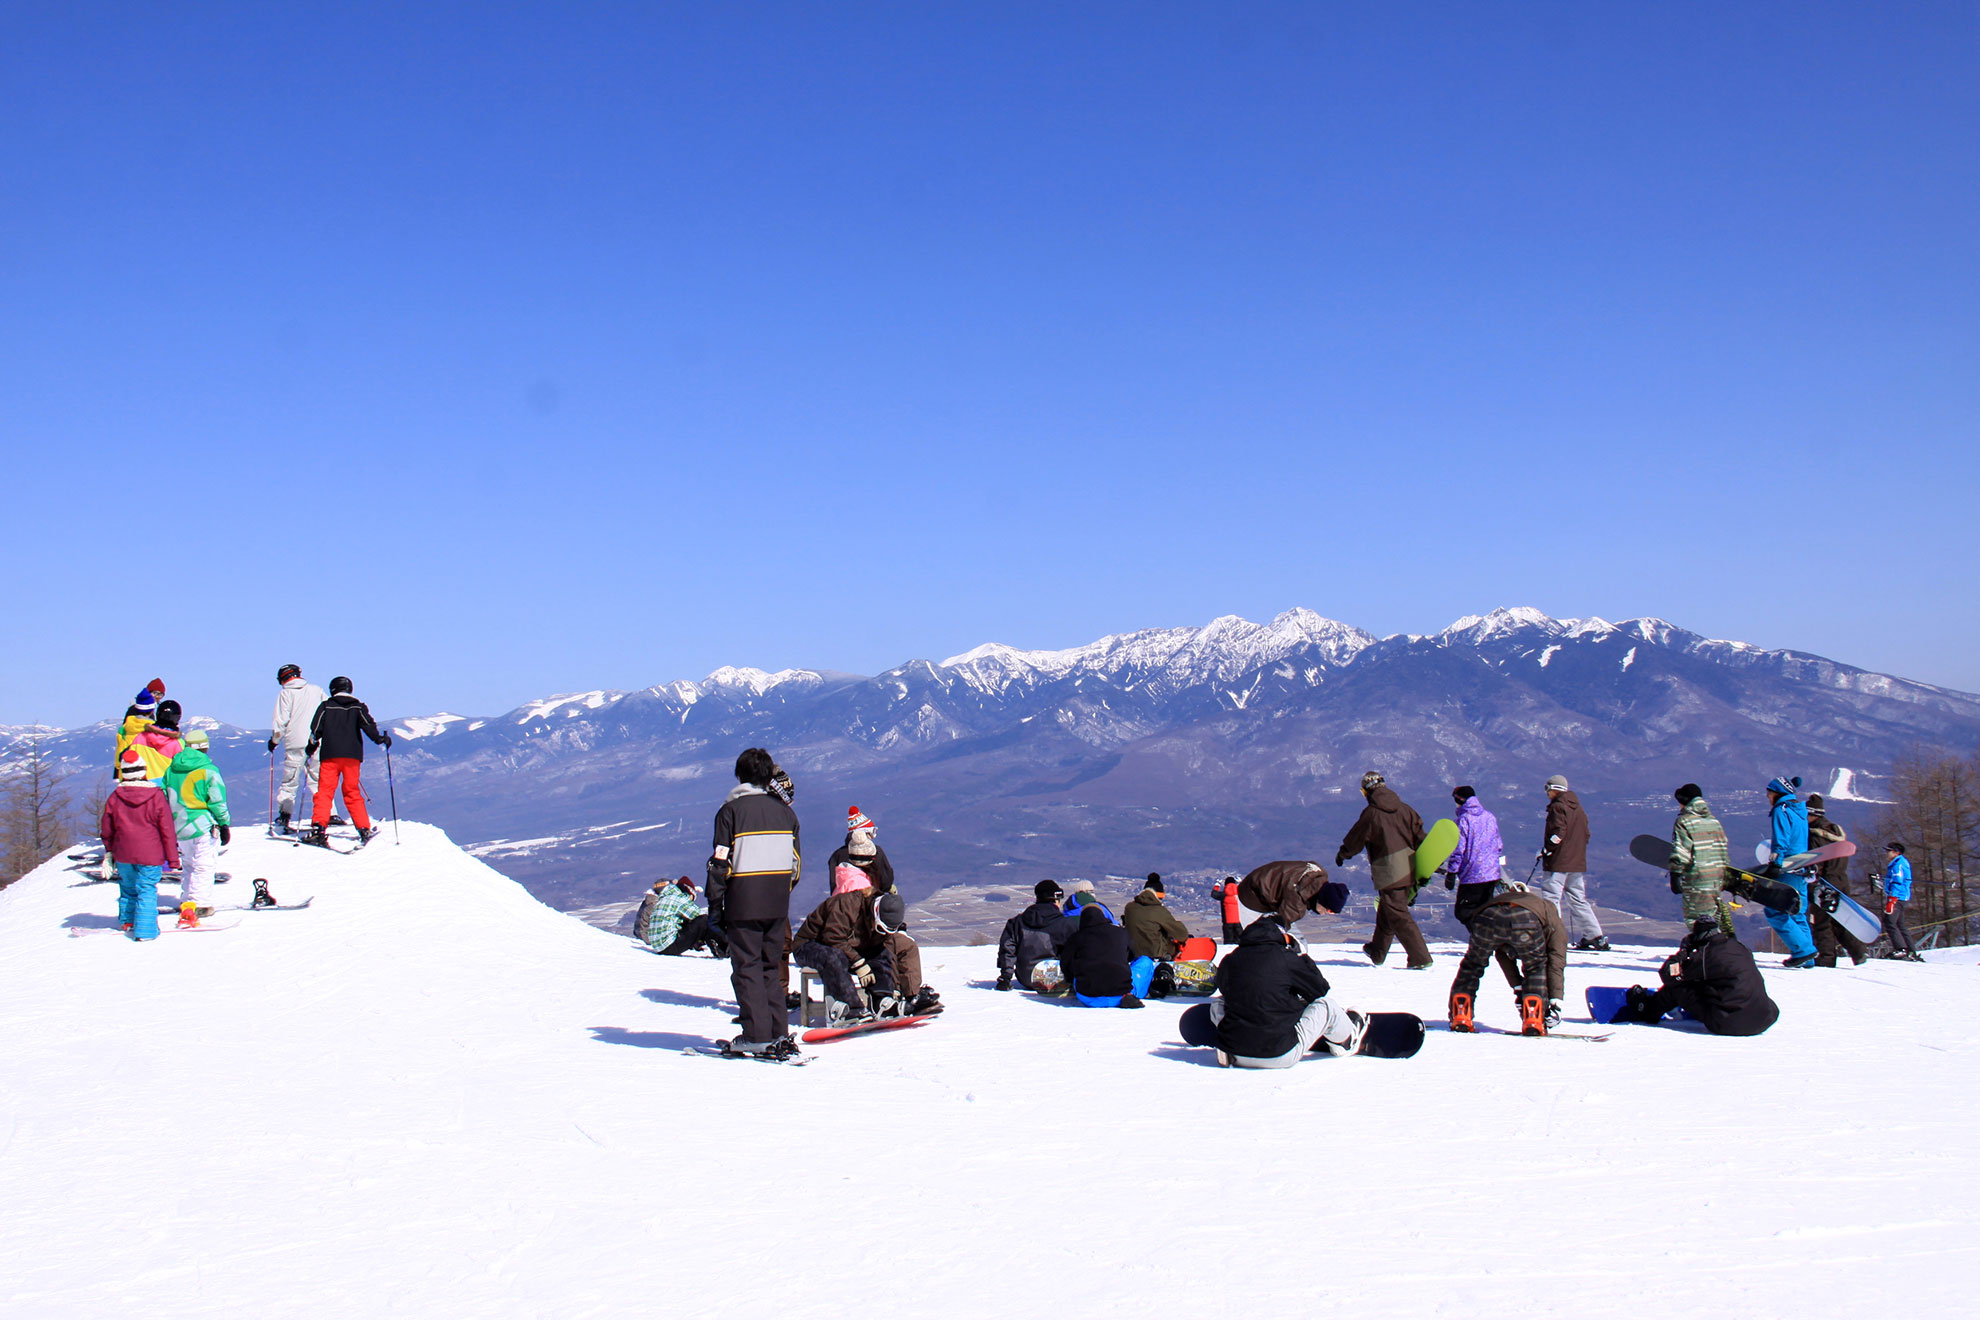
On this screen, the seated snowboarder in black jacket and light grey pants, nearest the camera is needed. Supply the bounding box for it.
[1210,914,1368,1069]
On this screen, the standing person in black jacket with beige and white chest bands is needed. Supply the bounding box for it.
[707,748,800,1059]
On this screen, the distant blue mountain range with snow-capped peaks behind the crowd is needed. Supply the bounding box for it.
[19,608,1980,930]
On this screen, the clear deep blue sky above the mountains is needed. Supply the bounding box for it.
[0,2,1980,724]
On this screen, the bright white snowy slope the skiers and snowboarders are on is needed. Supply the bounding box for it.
[0,825,1980,1320]
